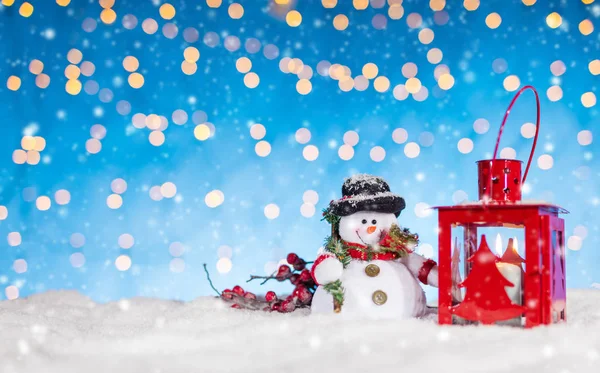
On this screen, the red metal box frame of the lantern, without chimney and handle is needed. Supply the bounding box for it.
[436,203,566,328]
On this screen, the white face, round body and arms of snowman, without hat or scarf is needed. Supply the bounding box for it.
[311,211,437,319]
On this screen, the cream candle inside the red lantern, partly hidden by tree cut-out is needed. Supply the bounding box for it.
[496,234,524,305]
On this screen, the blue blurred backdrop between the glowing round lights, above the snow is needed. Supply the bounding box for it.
[0,0,600,301]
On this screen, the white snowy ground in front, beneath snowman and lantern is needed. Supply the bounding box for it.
[0,290,600,373]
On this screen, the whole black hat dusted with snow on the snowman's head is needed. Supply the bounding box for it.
[328,174,406,216]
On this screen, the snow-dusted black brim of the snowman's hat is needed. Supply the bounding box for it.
[329,193,406,217]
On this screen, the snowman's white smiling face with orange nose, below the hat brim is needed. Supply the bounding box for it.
[339,211,398,245]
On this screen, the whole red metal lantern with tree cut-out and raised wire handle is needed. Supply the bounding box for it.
[436,86,567,328]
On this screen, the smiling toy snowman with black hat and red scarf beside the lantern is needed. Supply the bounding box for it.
[311,175,438,319]
